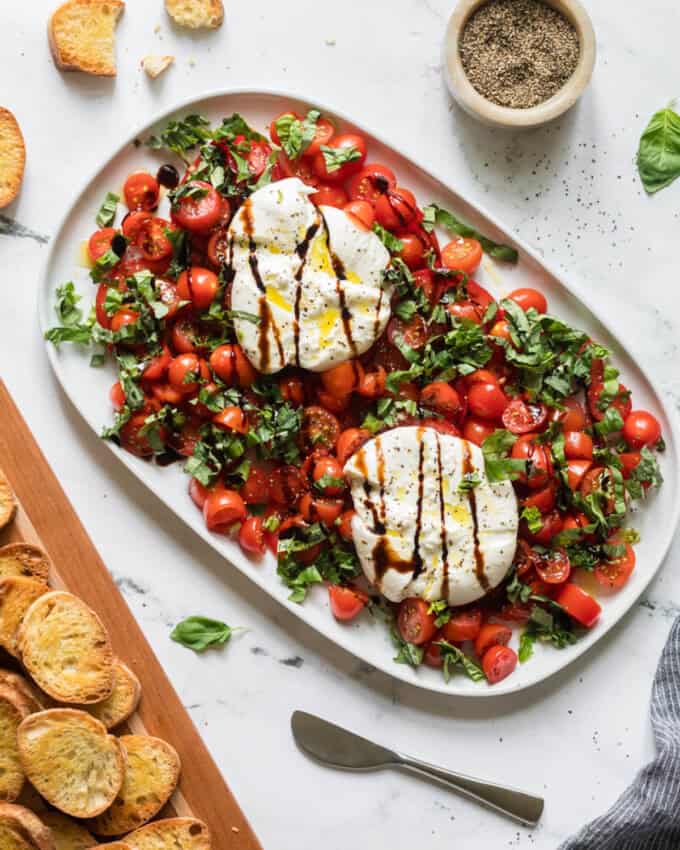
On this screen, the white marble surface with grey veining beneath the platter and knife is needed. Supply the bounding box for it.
[0,0,680,850]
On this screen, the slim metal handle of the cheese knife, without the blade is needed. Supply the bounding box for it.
[396,753,544,824]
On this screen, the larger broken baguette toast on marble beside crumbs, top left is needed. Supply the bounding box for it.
[48,0,125,77]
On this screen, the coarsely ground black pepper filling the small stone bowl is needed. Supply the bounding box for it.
[459,0,580,109]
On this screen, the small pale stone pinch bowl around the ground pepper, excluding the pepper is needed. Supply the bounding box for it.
[443,0,596,129]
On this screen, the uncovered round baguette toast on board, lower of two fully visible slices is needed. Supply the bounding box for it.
[17,708,125,818]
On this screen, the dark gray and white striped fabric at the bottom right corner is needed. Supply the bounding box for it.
[559,618,680,850]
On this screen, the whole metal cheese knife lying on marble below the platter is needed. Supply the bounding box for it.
[291,711,544,825]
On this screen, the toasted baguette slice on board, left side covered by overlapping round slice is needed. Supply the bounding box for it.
[88,735,180,835]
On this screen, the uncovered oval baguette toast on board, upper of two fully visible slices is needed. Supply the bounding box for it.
[17,590,113,705]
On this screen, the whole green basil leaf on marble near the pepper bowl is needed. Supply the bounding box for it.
[637,106,680,195]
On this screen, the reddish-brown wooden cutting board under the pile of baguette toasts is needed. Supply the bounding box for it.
[0,380,262,850]
